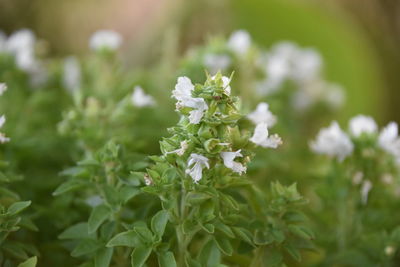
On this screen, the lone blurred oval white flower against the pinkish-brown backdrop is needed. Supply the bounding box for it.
[89,30,122,51]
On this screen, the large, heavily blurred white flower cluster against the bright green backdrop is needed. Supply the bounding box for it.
[257,42,344,110]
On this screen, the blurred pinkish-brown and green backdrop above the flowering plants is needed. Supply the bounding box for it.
[0,0,400,124]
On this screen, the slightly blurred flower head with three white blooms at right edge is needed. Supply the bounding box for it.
[310,115,400,204]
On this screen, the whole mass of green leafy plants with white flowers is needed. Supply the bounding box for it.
[0,30,400,267]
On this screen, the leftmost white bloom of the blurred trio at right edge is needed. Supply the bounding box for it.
[310,121,354,161]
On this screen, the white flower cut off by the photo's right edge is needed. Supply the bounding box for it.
[378,122,400,164]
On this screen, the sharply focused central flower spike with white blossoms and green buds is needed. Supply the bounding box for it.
[153,73,281,183]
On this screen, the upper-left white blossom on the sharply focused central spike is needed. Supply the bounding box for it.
[172,77,208,124]
